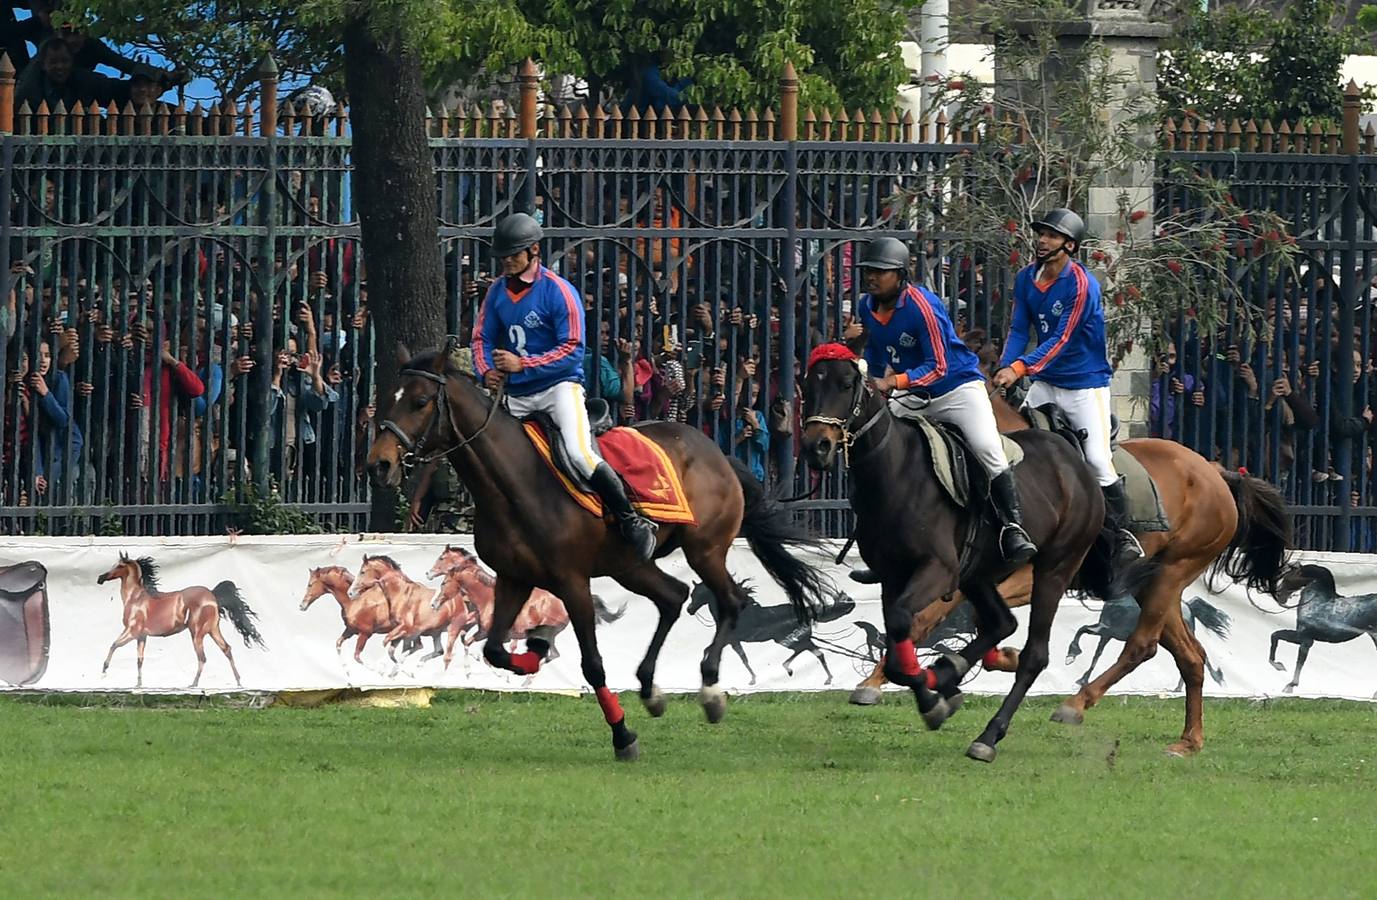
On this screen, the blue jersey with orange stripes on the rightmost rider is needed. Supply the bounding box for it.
[1000,260,1114,389]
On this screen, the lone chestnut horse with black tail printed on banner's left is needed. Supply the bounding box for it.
[95,553,264,688]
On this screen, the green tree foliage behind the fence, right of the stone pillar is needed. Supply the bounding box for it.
[1158,0,1377,121]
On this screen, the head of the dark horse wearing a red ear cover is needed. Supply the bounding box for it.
[799,344,884,471]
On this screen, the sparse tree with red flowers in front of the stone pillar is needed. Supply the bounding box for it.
[905,0,1296,354]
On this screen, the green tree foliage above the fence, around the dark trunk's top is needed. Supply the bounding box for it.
[75,0,920,106]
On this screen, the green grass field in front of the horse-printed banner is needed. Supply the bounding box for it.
[0,692,1377,899]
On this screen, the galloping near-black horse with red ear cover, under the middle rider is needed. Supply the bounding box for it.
[801,345,1110,762]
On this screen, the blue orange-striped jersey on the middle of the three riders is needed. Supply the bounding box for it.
[859,285,985,396]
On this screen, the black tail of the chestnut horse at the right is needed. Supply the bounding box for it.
[1206,469,1293,594]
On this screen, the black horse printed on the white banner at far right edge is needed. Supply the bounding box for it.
[1267,564,1377,694]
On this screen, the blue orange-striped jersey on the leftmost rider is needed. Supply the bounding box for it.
[474,266,585,396]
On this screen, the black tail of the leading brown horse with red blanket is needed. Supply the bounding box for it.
[727,457,834,622]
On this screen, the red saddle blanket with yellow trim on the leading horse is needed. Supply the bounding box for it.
[523,421,698,524]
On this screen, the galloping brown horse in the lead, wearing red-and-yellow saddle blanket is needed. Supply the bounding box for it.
[368,341,829,760]
